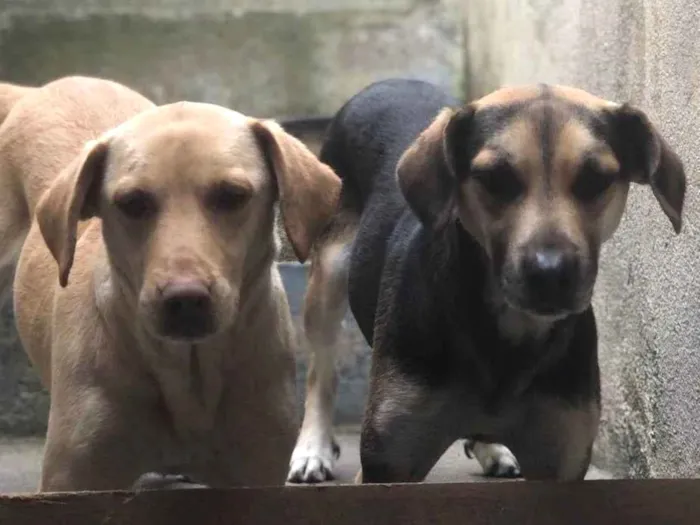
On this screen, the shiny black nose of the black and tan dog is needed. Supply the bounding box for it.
[522,248,578,313]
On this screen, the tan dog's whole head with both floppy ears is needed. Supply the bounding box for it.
[37,103,340,341]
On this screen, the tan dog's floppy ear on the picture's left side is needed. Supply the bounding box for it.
[36,140,108,287]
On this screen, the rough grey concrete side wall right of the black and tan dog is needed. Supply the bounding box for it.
[464,0,700,477]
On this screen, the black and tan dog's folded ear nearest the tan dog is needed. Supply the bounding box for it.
[396,106,473,229]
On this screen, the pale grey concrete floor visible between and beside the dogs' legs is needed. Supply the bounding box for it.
[0,428,611,494]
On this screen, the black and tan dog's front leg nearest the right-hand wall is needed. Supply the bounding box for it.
[508,399,600,481]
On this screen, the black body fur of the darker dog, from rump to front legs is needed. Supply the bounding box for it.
[321,80,600,482]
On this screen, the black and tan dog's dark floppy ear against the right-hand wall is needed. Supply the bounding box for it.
[615,104,686,233]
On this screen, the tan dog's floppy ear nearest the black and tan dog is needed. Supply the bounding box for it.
[251,120,341,262]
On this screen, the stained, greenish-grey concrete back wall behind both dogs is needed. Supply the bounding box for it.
[0,0,463,435]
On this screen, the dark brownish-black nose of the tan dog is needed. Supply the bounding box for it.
[161,280,214,340]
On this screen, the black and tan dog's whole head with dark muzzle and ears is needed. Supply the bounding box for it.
[397,86,686,318]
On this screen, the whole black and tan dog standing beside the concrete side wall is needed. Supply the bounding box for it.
[289,80,685,483]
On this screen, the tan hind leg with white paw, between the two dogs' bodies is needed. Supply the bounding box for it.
[287,221,355,483]
